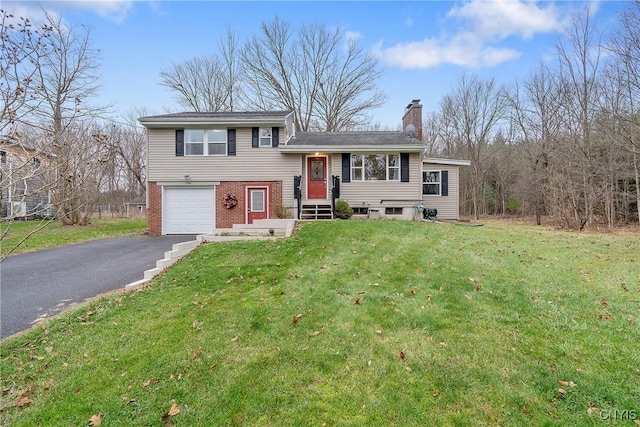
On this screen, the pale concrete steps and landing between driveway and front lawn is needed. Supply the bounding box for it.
[125,219,296,290]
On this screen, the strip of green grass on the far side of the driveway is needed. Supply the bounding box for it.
[0,218,147,256]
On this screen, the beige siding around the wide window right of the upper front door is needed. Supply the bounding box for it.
[331,153,422,217]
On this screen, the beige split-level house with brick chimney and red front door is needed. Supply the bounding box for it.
[139,100,468,235]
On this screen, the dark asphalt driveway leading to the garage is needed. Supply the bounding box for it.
[0,235,195,338]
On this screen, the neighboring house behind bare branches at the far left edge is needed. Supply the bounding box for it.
[0,138,55,218]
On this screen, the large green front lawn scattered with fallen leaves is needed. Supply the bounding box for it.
[0,221,640,426]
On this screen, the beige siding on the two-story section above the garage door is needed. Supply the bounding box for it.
[147,128,301,204]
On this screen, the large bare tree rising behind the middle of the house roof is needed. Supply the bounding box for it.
[242,18,385,132]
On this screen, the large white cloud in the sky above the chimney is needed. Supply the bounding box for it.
[375,0,562,69]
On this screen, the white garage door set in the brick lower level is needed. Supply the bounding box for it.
[162,187,215,234]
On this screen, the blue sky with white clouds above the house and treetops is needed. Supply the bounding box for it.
[1,0,626,129]
